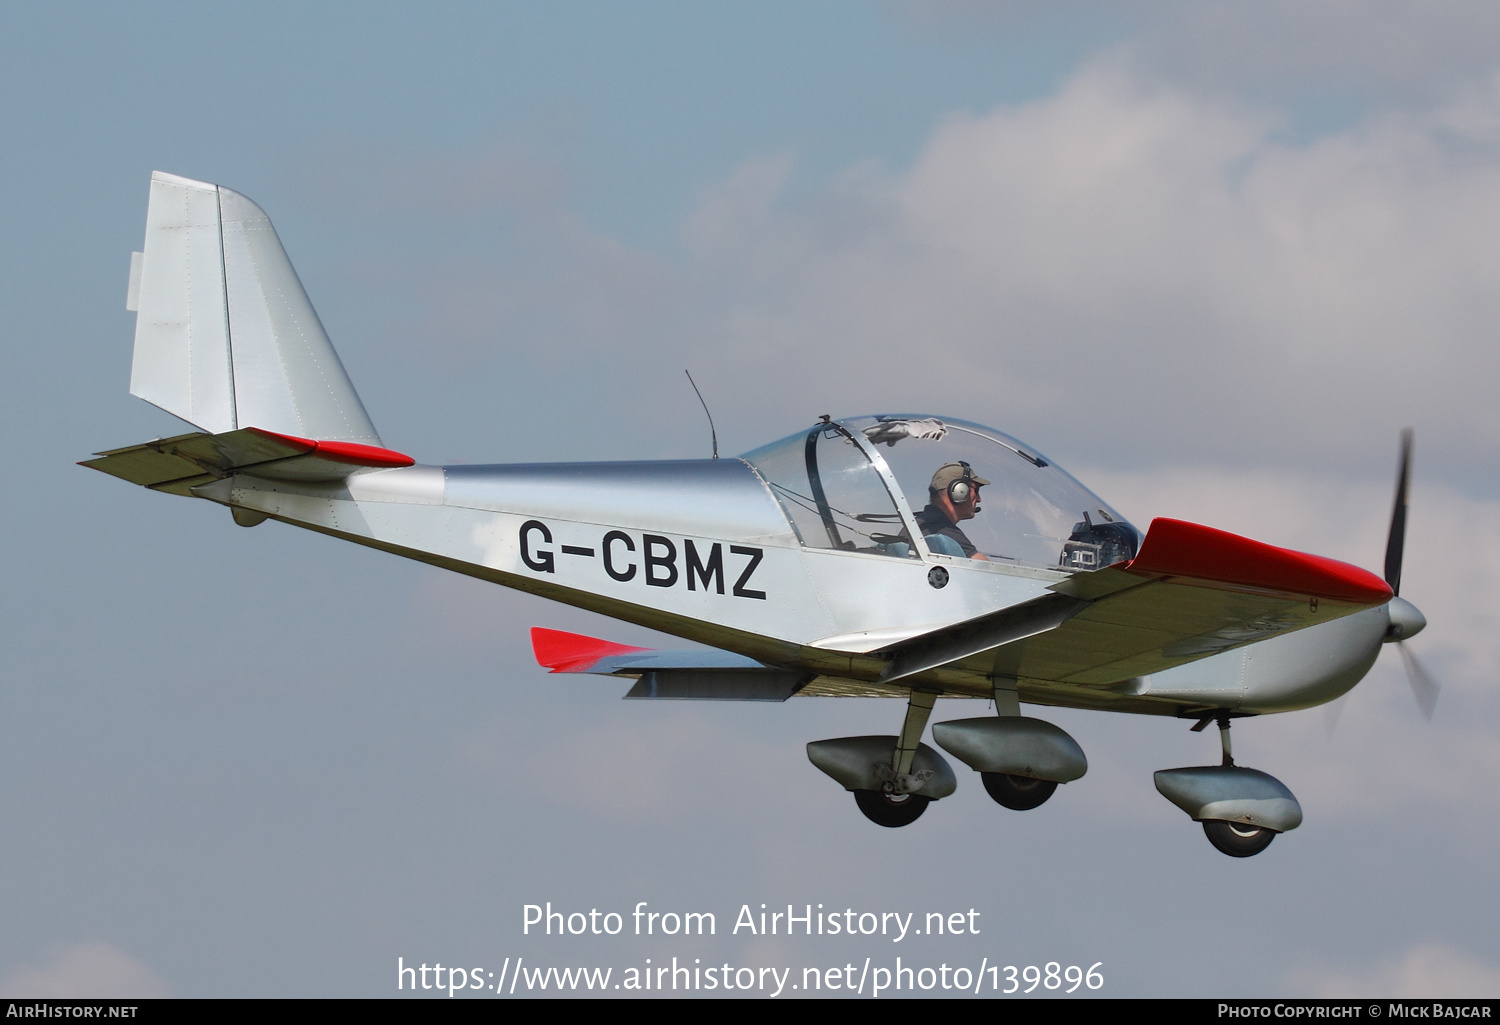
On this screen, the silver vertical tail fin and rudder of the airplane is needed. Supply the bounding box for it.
[131,171,383,447]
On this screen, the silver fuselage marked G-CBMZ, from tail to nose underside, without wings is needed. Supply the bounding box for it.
[194,459,1389,714]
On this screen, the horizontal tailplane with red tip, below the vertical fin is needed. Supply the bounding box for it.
[78,428,414,494]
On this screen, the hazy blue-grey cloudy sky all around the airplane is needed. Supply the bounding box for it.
[0,2,1500,996]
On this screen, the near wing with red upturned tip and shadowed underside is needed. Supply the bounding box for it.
[882,519,1391,686]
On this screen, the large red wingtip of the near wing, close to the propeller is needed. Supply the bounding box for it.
[1121,518,1391,605]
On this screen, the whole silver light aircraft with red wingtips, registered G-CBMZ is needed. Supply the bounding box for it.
[83,173,1436,857]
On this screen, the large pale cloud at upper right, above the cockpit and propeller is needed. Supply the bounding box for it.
[675,63,1500,480]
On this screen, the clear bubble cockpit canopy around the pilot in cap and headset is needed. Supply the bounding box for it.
[743,416,1142,570]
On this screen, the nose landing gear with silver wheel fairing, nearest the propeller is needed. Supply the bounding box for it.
[1157,710,1302,858]
